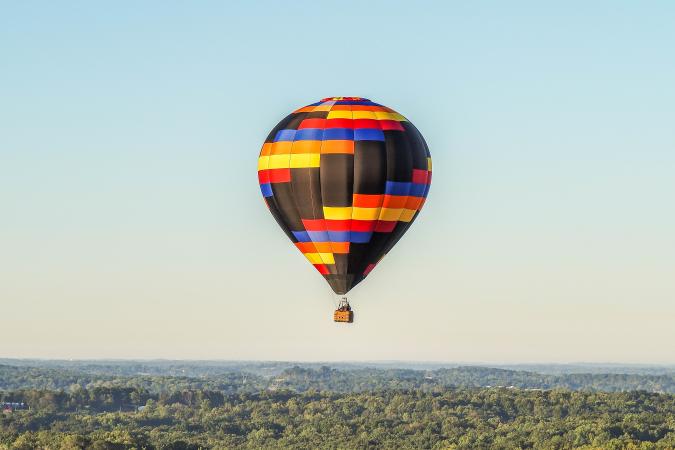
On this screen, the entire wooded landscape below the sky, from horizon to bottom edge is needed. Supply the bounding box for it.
[0,359,675,450]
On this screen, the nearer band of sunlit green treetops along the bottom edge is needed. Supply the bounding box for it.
[0,387,675,450]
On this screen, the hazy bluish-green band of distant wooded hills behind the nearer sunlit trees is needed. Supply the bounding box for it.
[0,365,675,394]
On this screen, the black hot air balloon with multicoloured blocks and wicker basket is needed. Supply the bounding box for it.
[258,97,431,322]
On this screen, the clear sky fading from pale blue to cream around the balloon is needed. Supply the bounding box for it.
[0,0,675,364]
